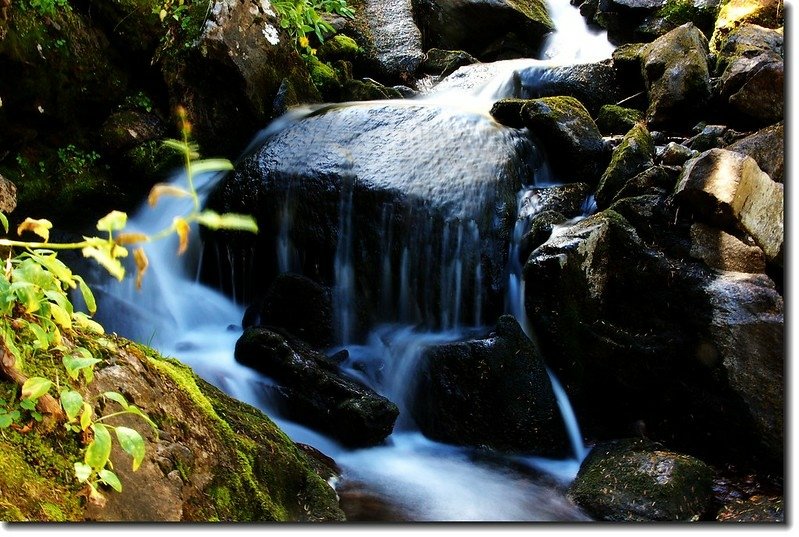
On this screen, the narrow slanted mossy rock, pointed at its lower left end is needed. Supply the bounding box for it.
[595,123,655,208]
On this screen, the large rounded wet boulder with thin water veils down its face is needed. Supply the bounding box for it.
[203,101,535,328]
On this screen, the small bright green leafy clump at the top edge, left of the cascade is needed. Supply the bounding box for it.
[272,0,355,55]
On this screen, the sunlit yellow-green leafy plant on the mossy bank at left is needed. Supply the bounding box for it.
[0,108,257,501]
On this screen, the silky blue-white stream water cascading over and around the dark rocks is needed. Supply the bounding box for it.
[99,0,612,521]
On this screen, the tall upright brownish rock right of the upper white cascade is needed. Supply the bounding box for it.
[641,23,710,128]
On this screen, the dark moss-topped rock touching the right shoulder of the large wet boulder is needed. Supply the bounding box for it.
[521,97,608,184]
